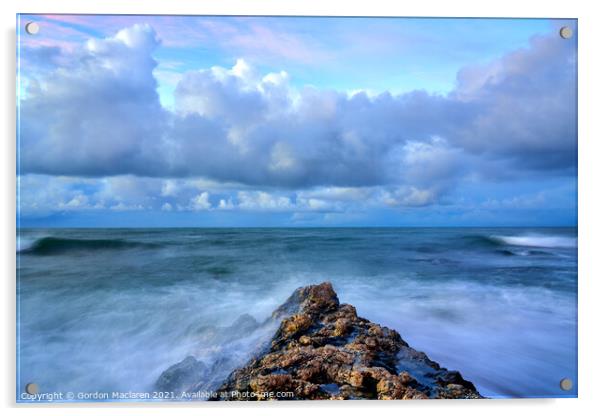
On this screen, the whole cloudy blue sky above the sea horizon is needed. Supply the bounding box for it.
[17,15,577,227]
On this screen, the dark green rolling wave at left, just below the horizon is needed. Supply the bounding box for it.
[19,237,156,255]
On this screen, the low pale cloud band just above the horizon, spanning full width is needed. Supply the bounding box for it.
[18,174,576,226]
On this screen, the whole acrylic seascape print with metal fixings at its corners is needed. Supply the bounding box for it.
[16,15,578,403]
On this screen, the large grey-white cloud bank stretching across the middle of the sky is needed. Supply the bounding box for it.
[20,24,576,210]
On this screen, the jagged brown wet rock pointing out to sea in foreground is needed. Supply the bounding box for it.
[217,282,481,400]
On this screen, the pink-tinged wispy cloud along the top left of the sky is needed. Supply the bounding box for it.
[18,14,330,63]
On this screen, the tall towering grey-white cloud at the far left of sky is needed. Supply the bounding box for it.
[20,25,168,176]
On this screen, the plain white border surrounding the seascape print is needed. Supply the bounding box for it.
[0,0,602,416]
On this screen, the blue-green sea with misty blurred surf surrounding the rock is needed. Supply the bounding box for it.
[17,228,577,399]
